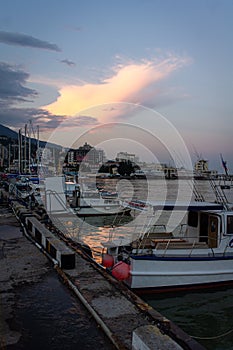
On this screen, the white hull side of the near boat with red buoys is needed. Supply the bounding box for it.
[126,257,233,289]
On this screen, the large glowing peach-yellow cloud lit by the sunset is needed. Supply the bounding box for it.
[45,54,190,121]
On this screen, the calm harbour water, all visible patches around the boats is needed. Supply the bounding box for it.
[64,180,233,350]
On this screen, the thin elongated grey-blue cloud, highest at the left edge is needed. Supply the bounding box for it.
[0,31,61,52]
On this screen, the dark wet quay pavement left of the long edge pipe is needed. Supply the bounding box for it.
[0,207,115,350]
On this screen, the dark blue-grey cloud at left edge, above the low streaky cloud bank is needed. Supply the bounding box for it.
[0,62,37,107]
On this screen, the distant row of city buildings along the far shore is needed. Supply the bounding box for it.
[0,126,225,179]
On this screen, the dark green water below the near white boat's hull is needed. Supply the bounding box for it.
[144,287,233,350]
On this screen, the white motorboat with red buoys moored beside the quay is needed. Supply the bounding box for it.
[102,180,233,292]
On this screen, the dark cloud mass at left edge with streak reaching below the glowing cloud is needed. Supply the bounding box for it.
[0,62,98,135]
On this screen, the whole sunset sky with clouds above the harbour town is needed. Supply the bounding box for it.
[0,0,233,173]
